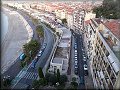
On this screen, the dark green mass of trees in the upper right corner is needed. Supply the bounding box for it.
[93,0,120,19]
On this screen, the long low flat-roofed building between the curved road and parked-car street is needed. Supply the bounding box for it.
[49,27,71,74]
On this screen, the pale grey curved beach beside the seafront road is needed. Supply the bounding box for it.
[1,8,28,73]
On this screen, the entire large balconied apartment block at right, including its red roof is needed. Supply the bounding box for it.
[84,19,120,89]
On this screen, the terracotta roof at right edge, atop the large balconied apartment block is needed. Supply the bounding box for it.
[103,20,120,40]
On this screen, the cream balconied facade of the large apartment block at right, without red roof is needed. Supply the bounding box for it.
[84,20,120,89]
